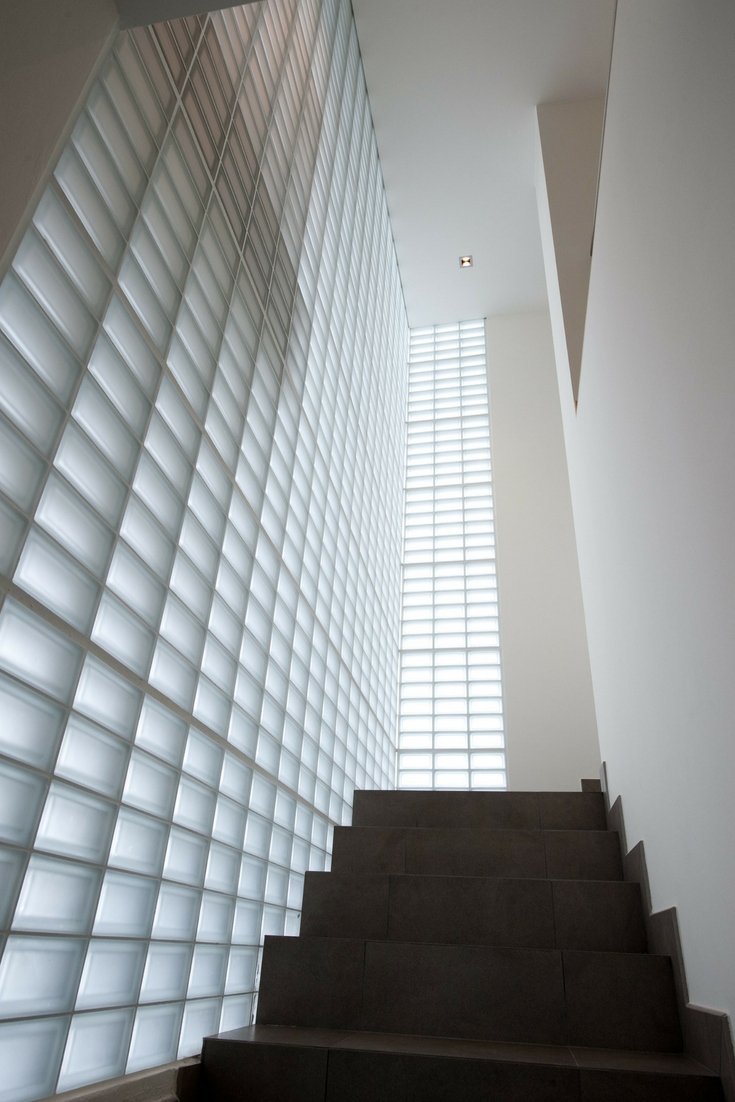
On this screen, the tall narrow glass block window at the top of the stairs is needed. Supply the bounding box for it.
[398,321,506,789]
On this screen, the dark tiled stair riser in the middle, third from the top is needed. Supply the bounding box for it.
[301,872,646,953]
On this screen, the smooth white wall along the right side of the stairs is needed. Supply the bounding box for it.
[560,0,735,1014]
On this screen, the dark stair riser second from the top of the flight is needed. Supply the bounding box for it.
[332,824,623,880]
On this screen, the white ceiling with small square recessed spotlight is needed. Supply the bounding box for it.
[353,0,615,325]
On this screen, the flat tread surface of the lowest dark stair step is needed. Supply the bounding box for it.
[209,1025,717,1079]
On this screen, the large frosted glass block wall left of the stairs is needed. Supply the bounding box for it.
[0,0,408,1102]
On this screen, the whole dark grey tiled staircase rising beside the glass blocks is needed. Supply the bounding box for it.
[202,791,723,1102]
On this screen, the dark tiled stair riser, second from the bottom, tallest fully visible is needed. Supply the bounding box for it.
[258,937,682,1052]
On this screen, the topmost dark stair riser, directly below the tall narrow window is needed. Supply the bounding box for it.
[353,790,607,830]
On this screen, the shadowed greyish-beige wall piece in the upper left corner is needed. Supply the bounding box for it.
[0,0,117,279]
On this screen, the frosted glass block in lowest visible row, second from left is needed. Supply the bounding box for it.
[56,1009,134,1091]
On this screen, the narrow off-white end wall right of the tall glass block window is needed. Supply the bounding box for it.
[486,313,599,791]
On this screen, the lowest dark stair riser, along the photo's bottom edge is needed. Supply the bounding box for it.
[201,1038,722,1102]
